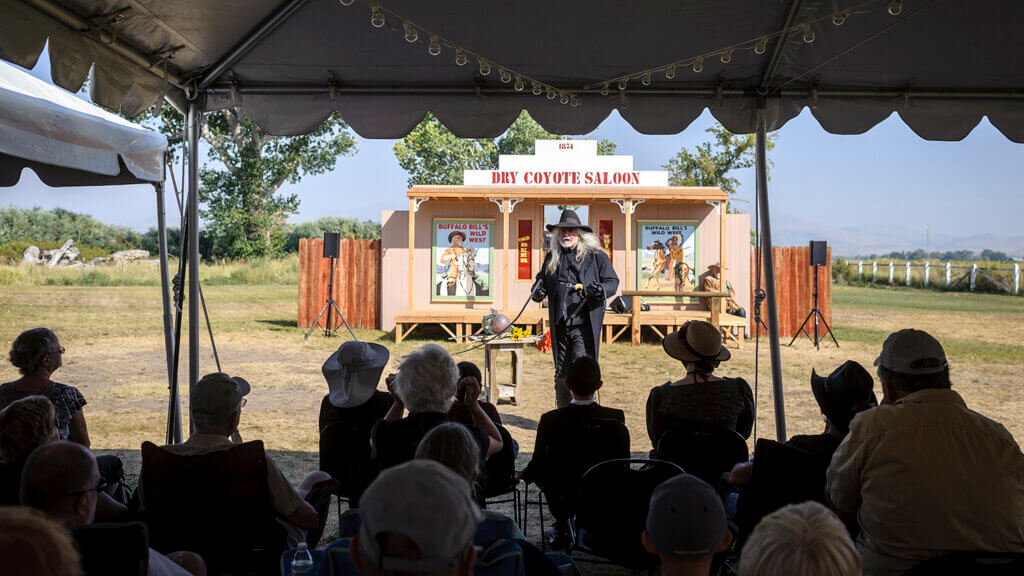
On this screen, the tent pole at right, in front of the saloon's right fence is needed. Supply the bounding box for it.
[756,97,786,442]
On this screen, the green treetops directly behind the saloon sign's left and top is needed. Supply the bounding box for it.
[392,111,615,187]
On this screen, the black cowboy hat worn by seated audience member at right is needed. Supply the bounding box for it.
[811,360,879,433]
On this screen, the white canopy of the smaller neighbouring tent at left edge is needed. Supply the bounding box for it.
[0,58,167,187]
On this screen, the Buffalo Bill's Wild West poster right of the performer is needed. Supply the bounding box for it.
[637,220,698,301]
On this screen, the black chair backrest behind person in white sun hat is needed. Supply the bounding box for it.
[319,422,371,496]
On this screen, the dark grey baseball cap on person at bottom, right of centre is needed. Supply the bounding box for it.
[647,474,729,557]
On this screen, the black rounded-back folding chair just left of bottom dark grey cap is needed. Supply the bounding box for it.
[569,458,683,570]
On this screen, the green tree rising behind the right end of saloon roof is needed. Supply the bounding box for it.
[662,124,776,211]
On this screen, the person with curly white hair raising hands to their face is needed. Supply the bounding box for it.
[371,344,502,470]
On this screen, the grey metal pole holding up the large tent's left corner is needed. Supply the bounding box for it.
[186,99,202,436]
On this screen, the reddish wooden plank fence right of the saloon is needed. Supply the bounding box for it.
[748,246,835,336]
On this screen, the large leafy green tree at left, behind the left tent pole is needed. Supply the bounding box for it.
[130,106,355,258]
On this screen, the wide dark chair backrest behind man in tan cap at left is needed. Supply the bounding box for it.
[139,440,285,558]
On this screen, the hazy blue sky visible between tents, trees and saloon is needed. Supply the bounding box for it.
[0,49,1024,256]
